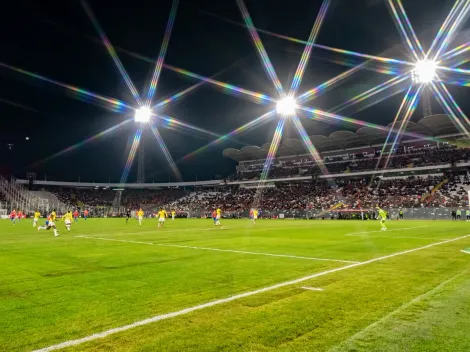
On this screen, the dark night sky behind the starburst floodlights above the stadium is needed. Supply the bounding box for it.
[0,0,470,182]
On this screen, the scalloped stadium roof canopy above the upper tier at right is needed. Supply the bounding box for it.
[223,114,461,161]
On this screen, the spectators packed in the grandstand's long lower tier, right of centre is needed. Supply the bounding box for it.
[168,172,470,212]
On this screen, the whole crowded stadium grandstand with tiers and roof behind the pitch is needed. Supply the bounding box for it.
[2,115,470,218]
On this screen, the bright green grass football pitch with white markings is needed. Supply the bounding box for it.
[0,219,470,352]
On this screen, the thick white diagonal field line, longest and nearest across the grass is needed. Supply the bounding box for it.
[33,235,470,352]
